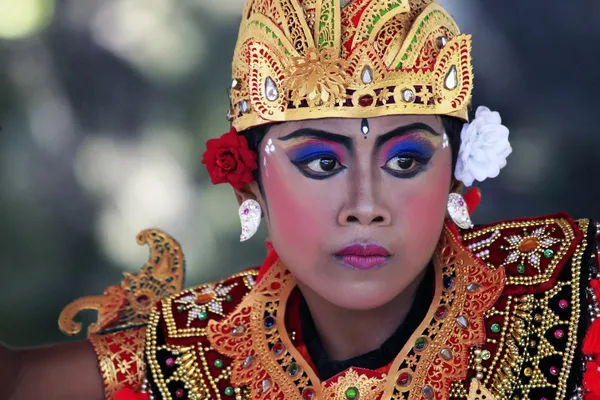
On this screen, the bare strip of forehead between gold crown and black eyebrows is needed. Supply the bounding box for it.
[269,115,444,137]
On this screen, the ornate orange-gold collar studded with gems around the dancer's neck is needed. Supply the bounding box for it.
[207,224,505,400]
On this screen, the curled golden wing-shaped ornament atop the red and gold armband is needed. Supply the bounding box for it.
[58,229,185,336]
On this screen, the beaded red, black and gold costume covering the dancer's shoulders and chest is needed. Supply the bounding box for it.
[62,214,600,400]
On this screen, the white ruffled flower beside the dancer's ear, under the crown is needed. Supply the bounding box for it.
[454,106,512,186]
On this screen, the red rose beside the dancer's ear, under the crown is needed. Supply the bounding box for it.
[202,128,258,189]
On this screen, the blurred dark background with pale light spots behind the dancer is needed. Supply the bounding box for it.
[0,0,600,346]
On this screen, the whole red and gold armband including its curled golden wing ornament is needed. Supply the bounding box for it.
[59,230,185,400]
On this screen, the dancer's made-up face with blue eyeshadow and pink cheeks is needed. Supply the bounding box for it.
[258,115,452,310]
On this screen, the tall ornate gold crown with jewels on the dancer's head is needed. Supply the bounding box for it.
[229,0,473,131]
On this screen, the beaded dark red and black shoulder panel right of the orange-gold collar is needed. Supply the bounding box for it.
[451,214,589,399]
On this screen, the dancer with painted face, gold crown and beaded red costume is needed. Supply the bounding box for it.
[0,0,600,400]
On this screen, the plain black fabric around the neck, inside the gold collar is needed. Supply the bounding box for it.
[300,265,435,380]
